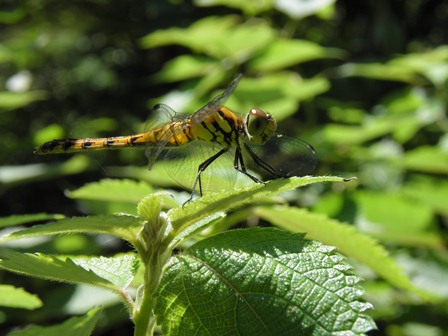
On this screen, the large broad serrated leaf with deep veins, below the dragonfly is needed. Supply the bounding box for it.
[155,228,375,336]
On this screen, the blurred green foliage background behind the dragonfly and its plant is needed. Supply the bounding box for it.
[0,0,448,335]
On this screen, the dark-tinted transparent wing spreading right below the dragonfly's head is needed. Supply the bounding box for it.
[243,134,318,181]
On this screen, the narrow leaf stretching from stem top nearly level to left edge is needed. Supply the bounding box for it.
[0,215,143,243]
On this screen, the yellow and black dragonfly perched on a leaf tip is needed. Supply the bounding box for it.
[34,74,317,202]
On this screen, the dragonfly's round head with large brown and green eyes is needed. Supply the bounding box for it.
[244,108,277,145]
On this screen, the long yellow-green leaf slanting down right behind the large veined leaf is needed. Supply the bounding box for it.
[255,207,418,293]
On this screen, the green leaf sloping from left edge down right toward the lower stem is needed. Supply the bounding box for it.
[0,249,119,291]
